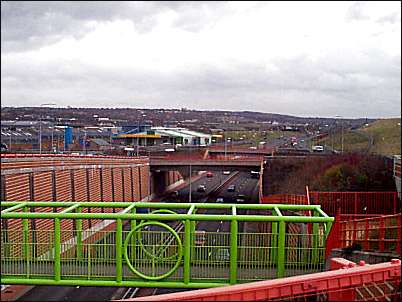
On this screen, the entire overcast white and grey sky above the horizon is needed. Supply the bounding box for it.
[1,1,401,118]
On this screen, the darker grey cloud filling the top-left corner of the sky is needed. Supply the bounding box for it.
[1,1,159,51]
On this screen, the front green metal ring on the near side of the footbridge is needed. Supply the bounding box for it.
[124,221,183,280]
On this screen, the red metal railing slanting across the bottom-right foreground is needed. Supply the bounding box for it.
[122,258,401,301]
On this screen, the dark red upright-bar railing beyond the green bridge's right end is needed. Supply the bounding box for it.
[310,192,400,216]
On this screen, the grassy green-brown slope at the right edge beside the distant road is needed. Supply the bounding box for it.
[321,118,401,155]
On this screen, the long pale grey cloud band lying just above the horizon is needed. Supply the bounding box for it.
[2,52,401,117]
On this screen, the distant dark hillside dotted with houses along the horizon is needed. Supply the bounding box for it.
[1,107,374,128]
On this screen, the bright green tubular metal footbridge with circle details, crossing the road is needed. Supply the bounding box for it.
[1,202,333,288]
